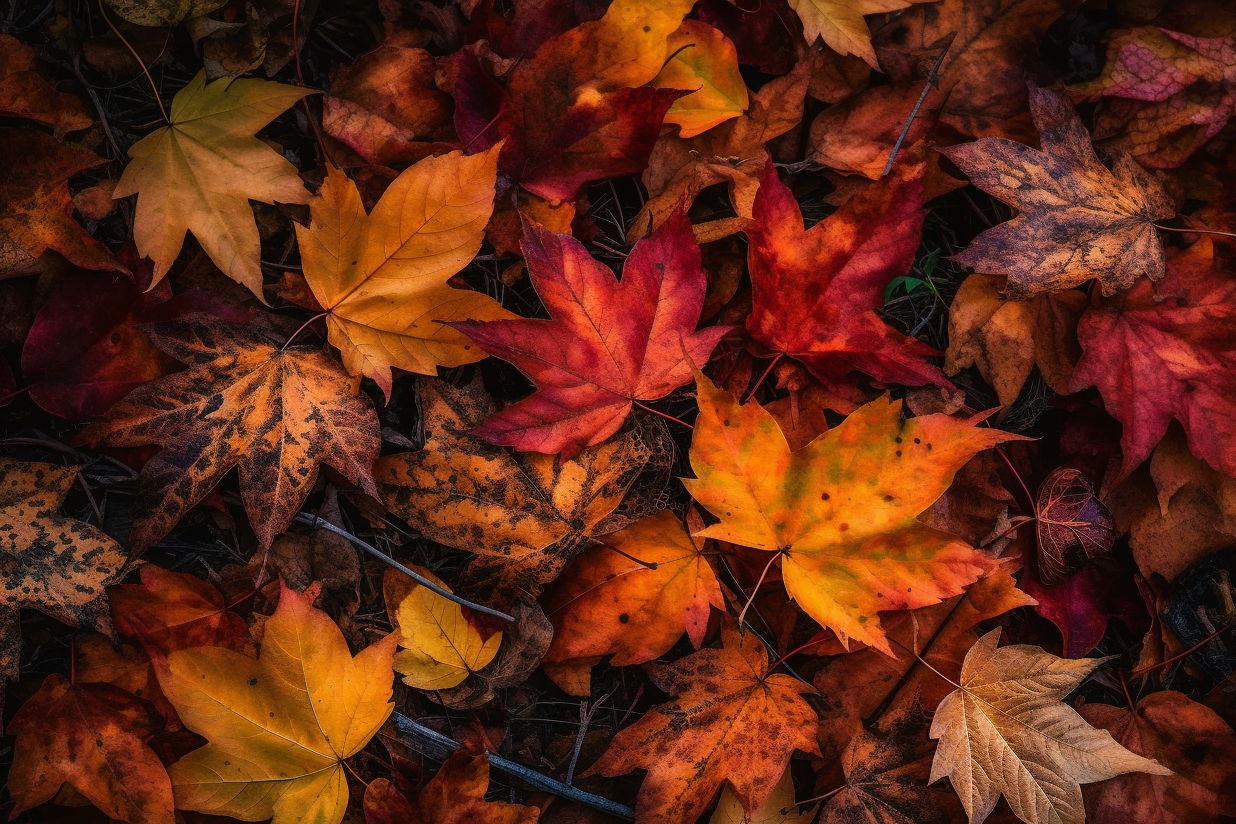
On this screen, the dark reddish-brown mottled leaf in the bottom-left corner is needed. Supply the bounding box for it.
[9,675,174,824]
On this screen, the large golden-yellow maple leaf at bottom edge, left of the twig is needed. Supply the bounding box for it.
[158,587,396,824]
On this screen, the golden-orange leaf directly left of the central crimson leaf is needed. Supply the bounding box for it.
[297,147,512,397]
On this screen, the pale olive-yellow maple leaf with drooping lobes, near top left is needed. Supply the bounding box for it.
[114,70,311,298]
